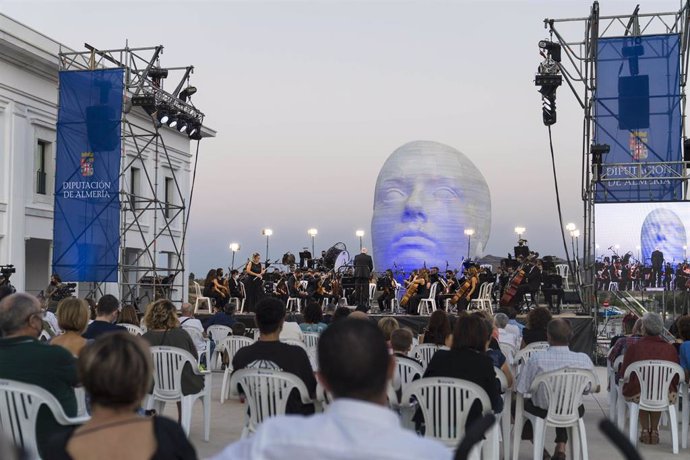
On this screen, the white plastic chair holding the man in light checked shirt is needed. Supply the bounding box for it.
[513,368,599,460]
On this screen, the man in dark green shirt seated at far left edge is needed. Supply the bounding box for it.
[0,294,77,457]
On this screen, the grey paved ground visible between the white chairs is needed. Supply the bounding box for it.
[171,367,676,460]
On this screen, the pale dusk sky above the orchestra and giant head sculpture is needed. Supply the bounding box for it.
[0,0,680,276]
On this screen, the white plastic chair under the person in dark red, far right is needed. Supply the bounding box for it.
[620,360,685,454]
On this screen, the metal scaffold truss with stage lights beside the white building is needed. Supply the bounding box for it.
[59,44,204,308]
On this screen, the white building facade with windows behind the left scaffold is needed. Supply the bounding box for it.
[0,14,210,300]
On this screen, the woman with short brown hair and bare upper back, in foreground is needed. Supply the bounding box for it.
[46,332,197,460]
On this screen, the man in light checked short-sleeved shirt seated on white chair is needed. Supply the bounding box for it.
[516,318,598,460]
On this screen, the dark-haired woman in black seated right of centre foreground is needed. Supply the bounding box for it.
[417,310,503,427]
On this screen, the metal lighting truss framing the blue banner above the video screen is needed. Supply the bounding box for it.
[544,0,690,318]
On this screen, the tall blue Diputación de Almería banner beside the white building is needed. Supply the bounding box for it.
[53,69,123,282]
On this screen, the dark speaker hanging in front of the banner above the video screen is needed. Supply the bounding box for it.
[618,75,649,129]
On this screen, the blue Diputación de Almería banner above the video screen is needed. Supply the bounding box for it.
[594,34,683,202]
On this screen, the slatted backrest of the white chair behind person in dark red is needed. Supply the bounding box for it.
[623,360,685,411]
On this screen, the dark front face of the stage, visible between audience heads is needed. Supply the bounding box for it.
[228,313,595,357]
